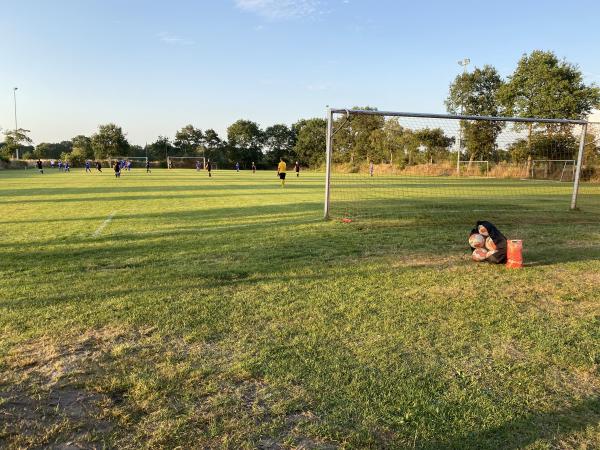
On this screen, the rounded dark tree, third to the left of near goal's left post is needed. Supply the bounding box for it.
[227,120,264,167]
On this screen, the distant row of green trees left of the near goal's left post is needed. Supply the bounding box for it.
[0,118,326,168]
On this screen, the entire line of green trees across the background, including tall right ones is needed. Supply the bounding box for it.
[0,50,600,168]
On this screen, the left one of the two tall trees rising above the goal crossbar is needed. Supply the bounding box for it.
[446,65,504,161]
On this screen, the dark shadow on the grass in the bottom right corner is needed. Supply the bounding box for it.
[418,397,600,450]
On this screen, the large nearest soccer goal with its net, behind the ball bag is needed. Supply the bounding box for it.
[325,109,587,219]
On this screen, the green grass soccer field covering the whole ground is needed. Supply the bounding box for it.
[0,170,600,449]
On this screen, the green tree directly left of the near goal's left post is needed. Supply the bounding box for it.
[292,118,327,167]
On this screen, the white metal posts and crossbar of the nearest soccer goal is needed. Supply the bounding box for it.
[323,107,589,220]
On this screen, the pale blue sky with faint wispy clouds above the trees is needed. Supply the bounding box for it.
[0,0,600,145]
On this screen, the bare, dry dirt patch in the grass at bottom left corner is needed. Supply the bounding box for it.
[0,329,127,449]
